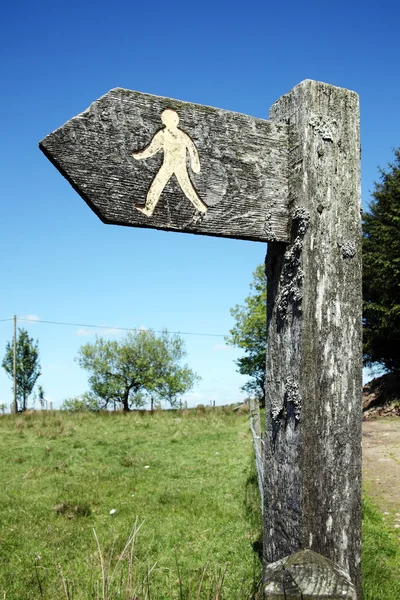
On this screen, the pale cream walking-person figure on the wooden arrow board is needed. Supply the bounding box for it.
[132,108,208,217]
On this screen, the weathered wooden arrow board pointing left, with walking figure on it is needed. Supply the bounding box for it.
[39,89,288,241]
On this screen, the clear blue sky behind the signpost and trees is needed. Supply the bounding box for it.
[0,0,400,406]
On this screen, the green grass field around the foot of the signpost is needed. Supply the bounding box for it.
[0,409,400,600]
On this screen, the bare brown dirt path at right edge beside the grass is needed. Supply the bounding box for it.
[363,419,400,529]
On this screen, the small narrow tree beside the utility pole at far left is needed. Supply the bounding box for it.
[2,329,41,411]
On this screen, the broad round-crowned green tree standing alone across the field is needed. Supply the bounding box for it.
[77,330,199,411]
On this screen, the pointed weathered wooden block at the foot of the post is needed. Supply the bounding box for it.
[264,550,357,600]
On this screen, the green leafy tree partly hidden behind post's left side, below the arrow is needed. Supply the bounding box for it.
[225,265,267,406]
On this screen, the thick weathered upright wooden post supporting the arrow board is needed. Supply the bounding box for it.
[264,80,362,599]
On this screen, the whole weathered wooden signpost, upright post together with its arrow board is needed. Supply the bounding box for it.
[40,80,362,600]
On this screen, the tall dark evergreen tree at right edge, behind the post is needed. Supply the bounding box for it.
[363,148,400,372]
